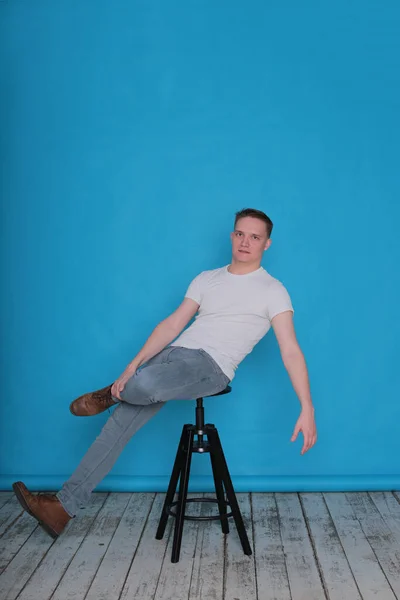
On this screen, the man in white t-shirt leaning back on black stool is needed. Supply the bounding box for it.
[13,208,317,537]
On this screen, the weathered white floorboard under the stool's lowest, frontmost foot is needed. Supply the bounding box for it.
[154,494,202,600]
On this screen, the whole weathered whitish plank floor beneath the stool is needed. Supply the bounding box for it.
[0,492,400,600]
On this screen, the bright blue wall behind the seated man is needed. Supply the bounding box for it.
[0,0,400,490]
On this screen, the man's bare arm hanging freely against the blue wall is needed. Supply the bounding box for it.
[271,311,317,454]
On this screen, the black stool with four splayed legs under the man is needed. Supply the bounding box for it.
[156,385,252,563]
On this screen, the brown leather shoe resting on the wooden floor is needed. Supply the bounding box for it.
[13,481,72,538]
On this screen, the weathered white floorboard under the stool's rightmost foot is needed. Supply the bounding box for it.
[225,493,257,600]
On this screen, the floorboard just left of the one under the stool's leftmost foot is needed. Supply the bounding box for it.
[85,494,155,600]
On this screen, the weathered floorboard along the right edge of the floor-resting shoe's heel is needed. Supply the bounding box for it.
[18,493,108,600]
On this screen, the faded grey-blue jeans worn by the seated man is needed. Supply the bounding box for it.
[57,346,229,517]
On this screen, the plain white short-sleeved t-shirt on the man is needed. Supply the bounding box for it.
[171,265,294,380]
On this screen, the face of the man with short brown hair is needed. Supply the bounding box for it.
[231,217,271,263]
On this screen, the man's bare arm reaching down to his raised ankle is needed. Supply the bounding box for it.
[111,298,200,398]
